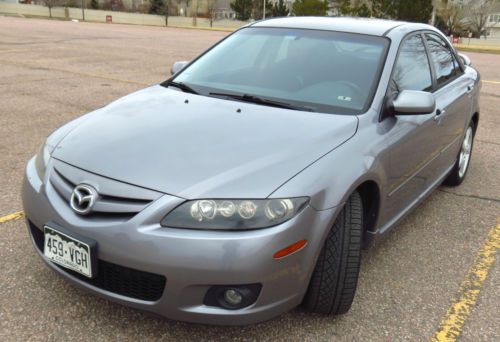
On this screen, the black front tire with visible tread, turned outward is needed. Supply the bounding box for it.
[303,192,363,315]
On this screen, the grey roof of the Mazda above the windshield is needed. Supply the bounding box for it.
[249,17,431,36]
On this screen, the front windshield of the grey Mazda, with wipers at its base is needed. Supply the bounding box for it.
[173,27,388,114]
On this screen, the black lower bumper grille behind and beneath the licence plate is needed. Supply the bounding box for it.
[29,222,166,301]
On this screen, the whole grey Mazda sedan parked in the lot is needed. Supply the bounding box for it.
[23,17,481,325]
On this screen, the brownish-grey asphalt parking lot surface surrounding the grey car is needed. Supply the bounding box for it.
[0,16,500,341]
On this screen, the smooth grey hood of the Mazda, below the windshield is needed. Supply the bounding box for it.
[53,86,358,199]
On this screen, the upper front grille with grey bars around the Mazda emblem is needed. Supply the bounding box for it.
[49,161,162,221]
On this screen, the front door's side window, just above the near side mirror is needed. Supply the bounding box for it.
[390,35,432,92]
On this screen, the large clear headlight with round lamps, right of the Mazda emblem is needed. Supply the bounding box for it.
[161,197,309,230]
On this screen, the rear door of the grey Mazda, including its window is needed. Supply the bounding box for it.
[425,32,474,179]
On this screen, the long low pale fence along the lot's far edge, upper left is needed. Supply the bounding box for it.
[0,2,247,30]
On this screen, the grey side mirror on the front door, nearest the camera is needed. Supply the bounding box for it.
[392,90,436,115]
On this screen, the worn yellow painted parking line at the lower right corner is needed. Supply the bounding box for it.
[431,224,500,342]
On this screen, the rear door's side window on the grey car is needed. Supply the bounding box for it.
[425,33,461,86]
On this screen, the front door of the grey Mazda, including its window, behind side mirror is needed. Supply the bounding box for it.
[381,33,441,222]
